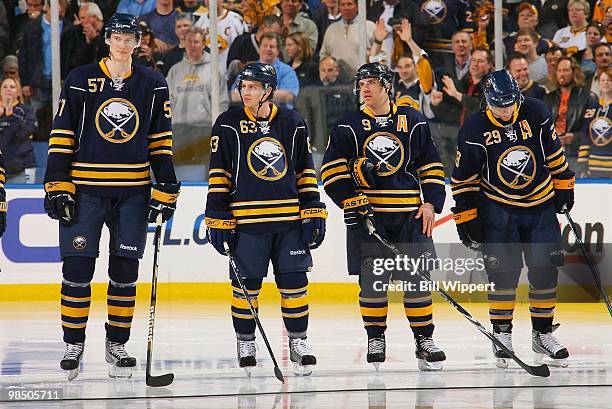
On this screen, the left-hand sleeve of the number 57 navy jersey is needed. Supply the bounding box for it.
[45,73,86,183]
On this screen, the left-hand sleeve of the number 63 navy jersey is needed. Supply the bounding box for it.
[206,115,237,212]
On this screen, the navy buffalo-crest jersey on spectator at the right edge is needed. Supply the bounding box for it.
[578,99,612,177]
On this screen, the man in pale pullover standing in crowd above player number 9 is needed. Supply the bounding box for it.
[319,0,376,75]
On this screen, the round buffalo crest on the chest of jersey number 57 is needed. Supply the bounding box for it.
[96,98,140,143]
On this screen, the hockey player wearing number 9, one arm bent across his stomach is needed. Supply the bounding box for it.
[321,63,446,370]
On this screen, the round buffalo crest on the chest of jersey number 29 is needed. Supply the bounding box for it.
[497,146,536,189]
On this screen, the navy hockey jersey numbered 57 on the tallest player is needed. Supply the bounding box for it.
[45,59,176,197]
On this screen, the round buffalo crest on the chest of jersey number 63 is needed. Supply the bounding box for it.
[247,137,287,181]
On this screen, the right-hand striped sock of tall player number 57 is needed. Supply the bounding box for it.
[106,280,136,344]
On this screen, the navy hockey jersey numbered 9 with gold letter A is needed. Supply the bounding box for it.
[321,105,445,214]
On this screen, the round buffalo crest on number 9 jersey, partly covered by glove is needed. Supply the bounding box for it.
[363,132,404,176]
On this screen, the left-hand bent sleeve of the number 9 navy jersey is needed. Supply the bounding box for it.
[321,124,357,208]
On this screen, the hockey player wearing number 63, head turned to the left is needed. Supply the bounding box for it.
[206,63,327,375]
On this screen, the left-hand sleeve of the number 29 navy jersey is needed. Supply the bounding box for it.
[451,127,486,209]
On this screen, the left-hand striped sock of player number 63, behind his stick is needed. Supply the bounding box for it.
[232,278,263,340]
